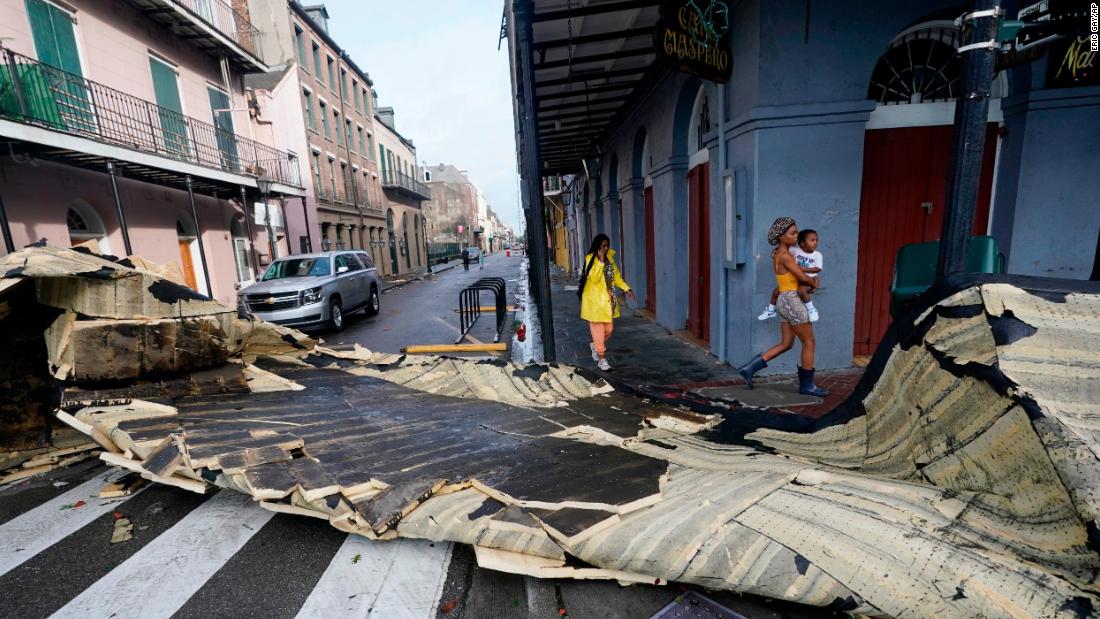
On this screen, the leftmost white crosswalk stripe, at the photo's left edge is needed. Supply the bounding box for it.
[0,468,130,575]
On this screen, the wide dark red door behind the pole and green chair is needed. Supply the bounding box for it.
[853,124,997,355]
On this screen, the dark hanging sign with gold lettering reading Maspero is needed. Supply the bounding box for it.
[653,0,733,82]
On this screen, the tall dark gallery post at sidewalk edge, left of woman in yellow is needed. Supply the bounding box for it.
[513,0,557,363]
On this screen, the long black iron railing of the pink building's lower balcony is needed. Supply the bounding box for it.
[0,47,301,187]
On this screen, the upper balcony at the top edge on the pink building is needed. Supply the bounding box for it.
[128,0,264,70]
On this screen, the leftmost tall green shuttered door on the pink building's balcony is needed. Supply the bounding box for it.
[22,0,96,132]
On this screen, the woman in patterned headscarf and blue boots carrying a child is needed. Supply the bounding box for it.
[737,217,828,397]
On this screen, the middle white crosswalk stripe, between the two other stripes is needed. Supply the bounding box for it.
[53,490,275,619]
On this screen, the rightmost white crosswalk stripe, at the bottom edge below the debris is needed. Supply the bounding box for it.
[298,535,451,619]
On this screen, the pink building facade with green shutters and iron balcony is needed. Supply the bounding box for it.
[0,0,316,303]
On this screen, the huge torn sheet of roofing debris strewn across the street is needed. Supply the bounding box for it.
[0,246,1100,619]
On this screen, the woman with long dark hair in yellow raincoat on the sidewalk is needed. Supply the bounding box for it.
[576,234,636,372]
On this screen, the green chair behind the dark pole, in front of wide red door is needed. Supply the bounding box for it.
[890,236,1004,317]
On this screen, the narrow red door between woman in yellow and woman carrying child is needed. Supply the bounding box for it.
[688,163,711,342]
